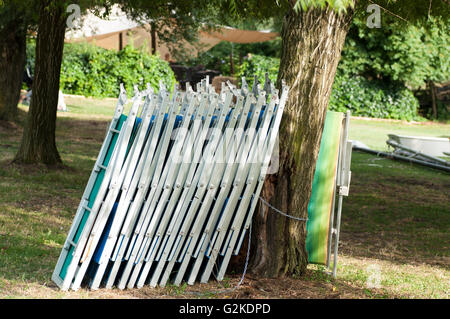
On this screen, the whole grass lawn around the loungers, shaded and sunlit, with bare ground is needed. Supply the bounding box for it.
[0,97,450,298]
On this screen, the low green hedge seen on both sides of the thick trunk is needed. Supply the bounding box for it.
[239,55,419,121]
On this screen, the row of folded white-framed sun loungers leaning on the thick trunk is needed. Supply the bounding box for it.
[52,77,289,290]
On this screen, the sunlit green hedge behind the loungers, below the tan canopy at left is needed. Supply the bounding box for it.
[28,44,176,97]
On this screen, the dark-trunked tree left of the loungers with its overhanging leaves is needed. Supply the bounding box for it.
[9,0,219,165]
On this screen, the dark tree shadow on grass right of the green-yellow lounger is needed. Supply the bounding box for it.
[340,152,450,269]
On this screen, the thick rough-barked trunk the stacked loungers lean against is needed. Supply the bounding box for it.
[250,8,353,277]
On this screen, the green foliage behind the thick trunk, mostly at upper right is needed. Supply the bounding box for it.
[219,8,450,120]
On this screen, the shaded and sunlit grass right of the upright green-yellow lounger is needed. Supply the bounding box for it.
[338,152,450,298]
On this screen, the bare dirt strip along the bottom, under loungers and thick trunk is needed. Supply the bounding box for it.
[0,269,368,299]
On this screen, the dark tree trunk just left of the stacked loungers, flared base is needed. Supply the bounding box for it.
[15,0,66,165]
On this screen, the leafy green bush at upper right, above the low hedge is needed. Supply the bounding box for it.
[339,17,450,89]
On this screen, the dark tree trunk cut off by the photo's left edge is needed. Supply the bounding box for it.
[0,20,26,121]
